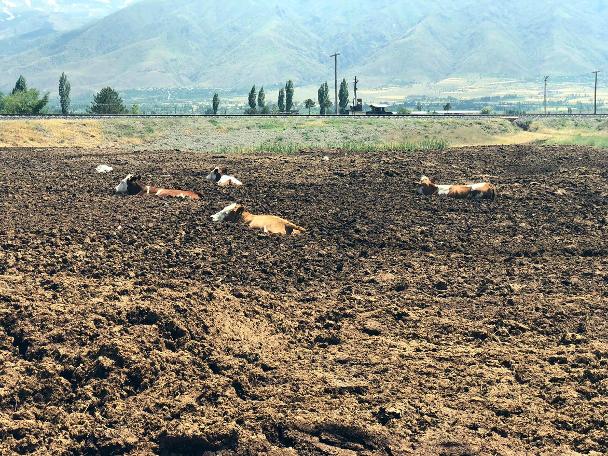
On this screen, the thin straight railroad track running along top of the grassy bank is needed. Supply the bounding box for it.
[0,114,608,121]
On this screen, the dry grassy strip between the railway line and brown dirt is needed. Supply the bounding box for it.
[0,117,608,153]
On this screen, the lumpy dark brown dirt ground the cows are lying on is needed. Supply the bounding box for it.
[0,147,608,455]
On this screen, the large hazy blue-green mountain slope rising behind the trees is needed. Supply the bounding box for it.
[0,0,608,91]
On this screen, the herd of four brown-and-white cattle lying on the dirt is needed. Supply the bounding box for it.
[116,166,496,235]
